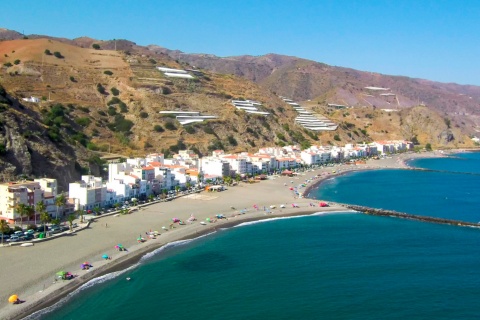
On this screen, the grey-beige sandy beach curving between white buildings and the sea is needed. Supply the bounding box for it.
[0,152,443,319]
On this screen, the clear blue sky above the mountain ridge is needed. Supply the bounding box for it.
[0,0,480,85]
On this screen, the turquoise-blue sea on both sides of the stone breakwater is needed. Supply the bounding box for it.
[30,153,480,320]
